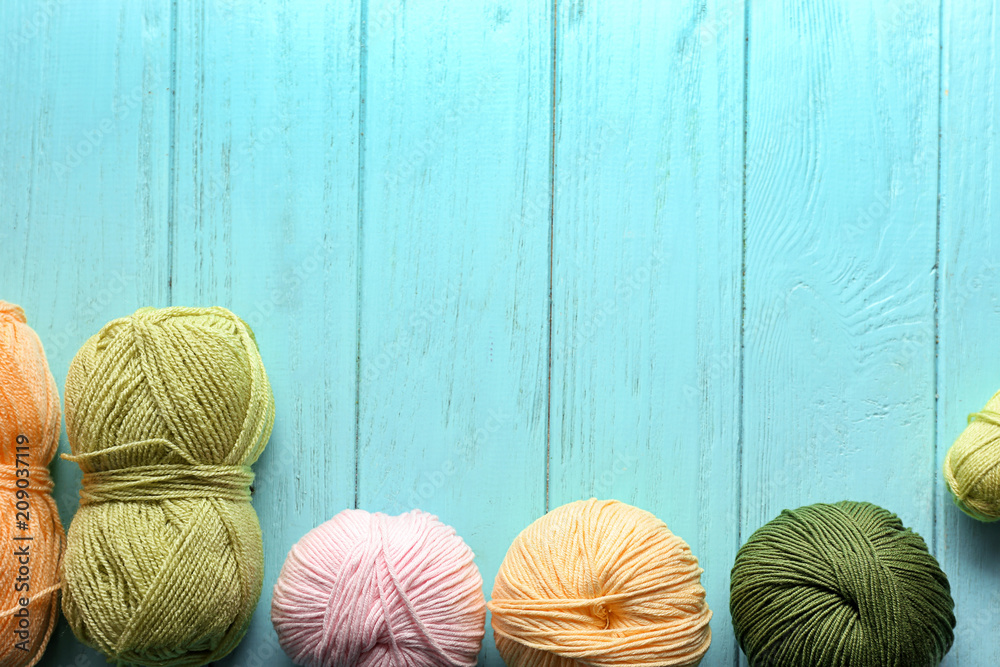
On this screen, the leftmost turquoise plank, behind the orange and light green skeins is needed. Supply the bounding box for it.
[0,0,170,665]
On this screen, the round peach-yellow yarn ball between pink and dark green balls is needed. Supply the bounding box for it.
[488,498,712,667]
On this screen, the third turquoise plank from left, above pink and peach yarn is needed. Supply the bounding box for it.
[358,0,552,665]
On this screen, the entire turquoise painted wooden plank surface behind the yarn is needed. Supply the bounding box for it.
[0,0,1000,667]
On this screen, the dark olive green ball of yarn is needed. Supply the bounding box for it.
[730,501,955,667]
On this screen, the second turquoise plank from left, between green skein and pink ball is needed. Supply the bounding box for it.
[172,0,361,665]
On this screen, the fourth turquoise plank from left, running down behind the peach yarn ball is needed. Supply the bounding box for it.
[549,0,744,665]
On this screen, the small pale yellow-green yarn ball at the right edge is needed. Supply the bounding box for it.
[944,392,1000,521]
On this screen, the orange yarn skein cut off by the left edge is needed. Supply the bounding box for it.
[0,301,65,667]
